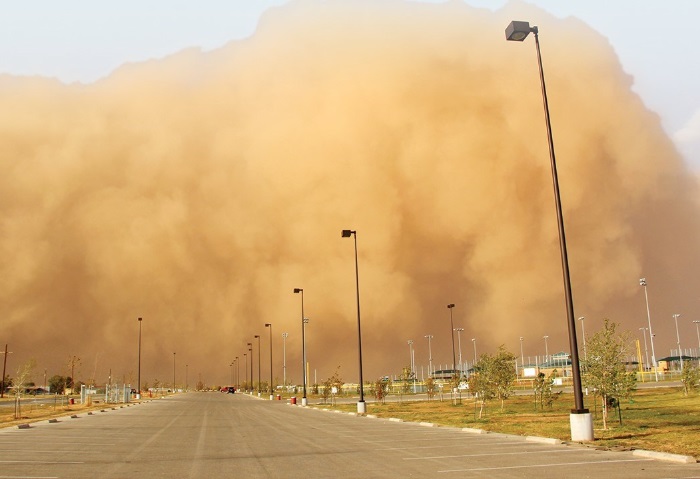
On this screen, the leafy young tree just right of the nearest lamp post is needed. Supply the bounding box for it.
[581,318,637,429]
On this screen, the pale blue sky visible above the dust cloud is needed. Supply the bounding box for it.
[0,0,700,171]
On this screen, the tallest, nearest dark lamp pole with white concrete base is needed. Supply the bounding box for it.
[506,21,593,441]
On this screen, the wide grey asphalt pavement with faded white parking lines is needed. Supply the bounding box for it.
[0,393,700,479]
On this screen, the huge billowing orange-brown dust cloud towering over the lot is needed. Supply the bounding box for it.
[0,0,700,385]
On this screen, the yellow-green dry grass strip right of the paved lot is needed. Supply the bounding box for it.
[324,388,700,458]
